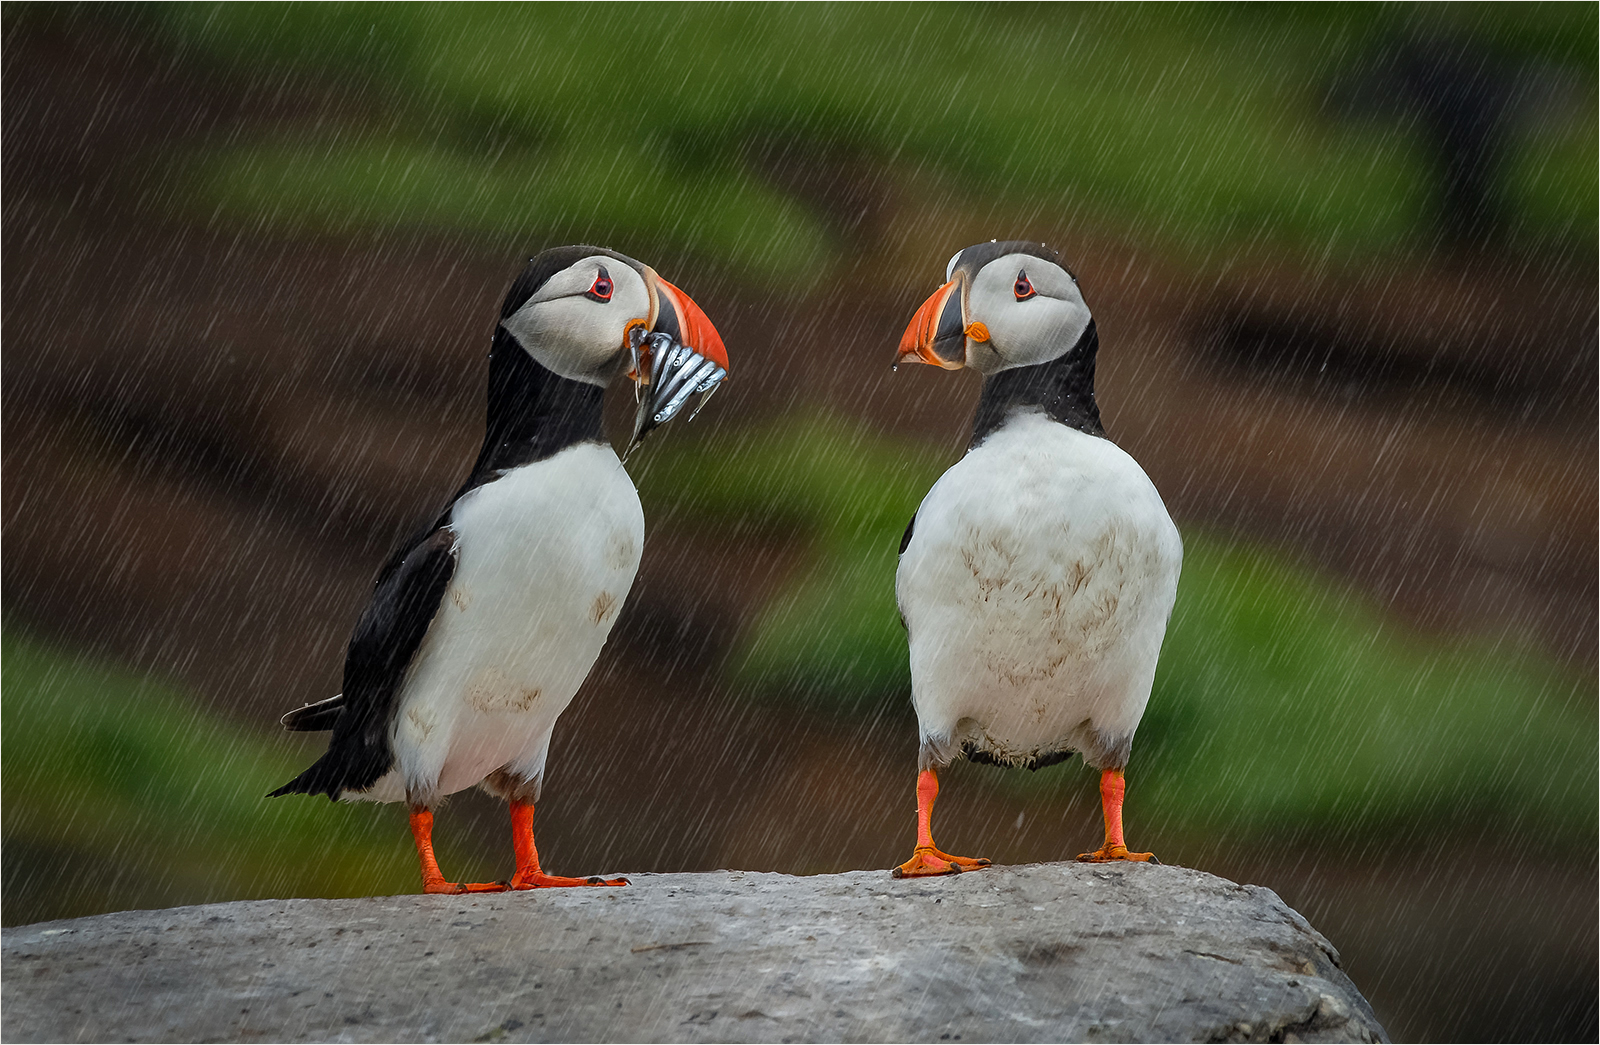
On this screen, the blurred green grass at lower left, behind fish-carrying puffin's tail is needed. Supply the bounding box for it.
[0,634,416,925]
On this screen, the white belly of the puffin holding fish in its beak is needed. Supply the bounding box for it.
[381,443,645,795]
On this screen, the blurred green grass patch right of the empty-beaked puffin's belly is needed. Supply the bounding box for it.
[1136,533,1600,848]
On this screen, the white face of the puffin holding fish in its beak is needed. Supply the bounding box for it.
[501,254,650,386]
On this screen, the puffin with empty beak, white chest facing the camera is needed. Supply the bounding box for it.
[894,240,1182,877]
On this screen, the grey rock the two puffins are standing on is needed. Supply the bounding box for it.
[0,864,1387,1042]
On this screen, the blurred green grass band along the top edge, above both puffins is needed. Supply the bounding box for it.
[144,3,1600,283]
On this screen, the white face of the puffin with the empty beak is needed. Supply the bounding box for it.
[952,254,1090,374]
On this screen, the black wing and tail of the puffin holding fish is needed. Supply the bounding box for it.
[269,527,456,799]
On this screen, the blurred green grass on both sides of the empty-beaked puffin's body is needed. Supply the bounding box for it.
[640,414,1600,848]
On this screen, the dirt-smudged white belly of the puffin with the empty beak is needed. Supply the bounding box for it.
[896,414,1182,763]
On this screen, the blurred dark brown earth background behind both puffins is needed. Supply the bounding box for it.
[0,10,1597,1040]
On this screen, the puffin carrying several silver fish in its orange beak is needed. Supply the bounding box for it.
[272,246,728,893]
